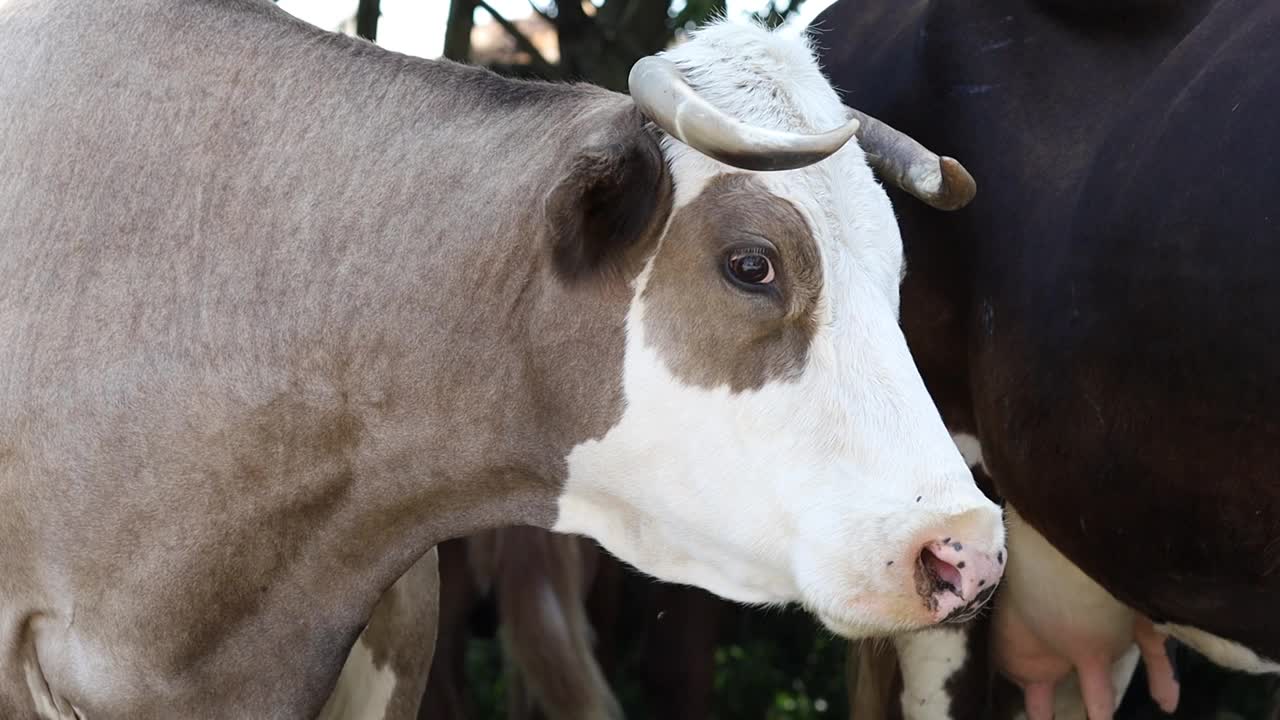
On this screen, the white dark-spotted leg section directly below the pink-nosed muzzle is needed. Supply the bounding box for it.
[893,626,970,720]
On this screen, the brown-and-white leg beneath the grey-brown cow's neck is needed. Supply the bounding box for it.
[319,547,440,720]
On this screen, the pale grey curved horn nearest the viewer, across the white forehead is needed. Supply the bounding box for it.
[628,55,859,170]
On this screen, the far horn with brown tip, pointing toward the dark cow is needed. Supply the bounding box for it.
[849,108,978,210]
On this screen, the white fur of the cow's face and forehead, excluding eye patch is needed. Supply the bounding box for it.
[556,19,1004,635]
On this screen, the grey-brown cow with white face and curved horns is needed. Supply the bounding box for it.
[0,0,1004,720]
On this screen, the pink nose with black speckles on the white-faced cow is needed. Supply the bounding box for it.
[915,537,1005,623]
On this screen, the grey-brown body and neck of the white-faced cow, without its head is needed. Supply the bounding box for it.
[0,3,634,719]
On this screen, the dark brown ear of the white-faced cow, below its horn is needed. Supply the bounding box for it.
[544,108,672,282]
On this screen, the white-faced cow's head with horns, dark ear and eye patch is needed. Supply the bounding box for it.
[548,24,1005,635]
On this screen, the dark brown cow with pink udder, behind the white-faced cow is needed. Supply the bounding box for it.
[814,0,1280,717]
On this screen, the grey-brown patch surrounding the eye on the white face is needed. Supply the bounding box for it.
[643,173,822,392]
